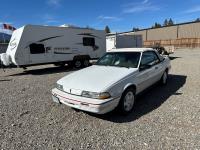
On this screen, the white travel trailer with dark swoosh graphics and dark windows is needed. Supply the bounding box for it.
[0,25,106,68]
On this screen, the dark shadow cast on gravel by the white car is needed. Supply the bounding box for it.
[88,75,187,123]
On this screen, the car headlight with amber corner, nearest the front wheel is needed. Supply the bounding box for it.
[82,91,111,99]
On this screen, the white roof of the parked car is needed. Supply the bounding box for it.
[107,48,154,52]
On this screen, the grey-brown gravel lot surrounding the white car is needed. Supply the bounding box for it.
[0,49,200,150]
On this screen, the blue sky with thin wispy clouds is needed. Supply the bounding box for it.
[0,0,200,32]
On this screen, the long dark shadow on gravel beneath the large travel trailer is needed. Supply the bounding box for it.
[9,66,78,76]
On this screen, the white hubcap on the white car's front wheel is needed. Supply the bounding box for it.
[124,91,135,111]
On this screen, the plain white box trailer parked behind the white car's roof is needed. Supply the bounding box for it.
[106,33,143,51]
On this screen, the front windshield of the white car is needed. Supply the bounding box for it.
[96,52,141,68]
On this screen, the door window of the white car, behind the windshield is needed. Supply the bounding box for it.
[141,52,159,65]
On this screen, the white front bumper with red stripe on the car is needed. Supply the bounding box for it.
[52,88,120,114]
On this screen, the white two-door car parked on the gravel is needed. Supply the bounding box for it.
[52,48,171,114]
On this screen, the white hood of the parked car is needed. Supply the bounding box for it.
[57,65,137,94]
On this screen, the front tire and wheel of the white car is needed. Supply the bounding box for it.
[118,88,136,115]
